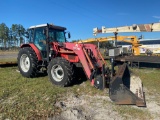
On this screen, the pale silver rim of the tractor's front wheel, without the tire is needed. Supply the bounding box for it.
[51,64,64,82]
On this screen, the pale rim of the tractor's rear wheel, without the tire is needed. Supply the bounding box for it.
[20,54,30,72]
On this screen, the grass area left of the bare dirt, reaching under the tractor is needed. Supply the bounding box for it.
[0,67,102,120]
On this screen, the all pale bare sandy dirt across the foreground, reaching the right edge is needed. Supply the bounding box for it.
[48,90,160,120]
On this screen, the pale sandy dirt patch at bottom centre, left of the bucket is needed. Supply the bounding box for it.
[49,95,122,120]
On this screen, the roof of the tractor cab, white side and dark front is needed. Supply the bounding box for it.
[29,24,66,30]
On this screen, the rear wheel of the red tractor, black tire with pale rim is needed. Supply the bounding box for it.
[17,47,38,77]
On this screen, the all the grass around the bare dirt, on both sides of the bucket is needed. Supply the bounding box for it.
[0,64,160,120]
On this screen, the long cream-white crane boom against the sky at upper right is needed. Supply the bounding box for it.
[93,22,160,35]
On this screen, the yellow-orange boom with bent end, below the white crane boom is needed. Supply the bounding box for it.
[77,36,141,55]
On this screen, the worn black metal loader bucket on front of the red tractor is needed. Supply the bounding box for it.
[109,63,146,107]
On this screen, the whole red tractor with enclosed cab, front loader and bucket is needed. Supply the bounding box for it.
[18,24,145,106]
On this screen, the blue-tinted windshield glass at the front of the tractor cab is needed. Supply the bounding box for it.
[49,29,66,42]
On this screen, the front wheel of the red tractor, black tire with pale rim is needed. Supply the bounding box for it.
[48,57,74,87]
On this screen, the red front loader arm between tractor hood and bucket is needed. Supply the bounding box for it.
[61,43,106,89]
